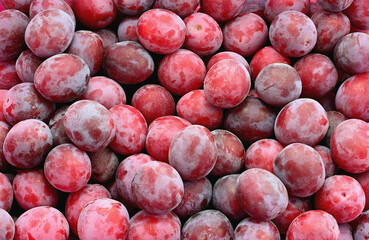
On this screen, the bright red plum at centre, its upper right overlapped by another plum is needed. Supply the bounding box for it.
[176,89,223,130]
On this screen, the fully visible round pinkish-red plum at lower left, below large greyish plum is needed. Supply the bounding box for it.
[44,143,91,192]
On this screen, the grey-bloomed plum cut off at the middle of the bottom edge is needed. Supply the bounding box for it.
[181,209,233,240]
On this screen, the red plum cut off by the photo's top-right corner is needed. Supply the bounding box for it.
[344,0,369,29]
